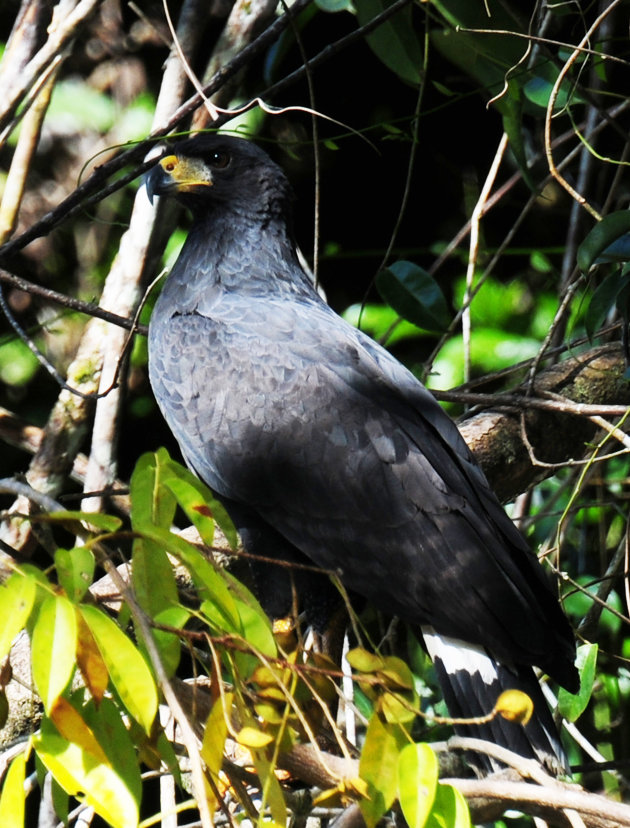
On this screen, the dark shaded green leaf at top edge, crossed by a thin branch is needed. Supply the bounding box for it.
[355,0,424,86]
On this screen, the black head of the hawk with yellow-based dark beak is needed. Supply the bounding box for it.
[146,134,290,218]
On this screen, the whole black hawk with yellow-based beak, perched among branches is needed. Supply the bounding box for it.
[147,134,578,770]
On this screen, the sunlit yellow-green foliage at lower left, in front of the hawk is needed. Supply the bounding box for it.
[0,449,470,828]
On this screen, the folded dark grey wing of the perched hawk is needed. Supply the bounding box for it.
[153,296,568,672]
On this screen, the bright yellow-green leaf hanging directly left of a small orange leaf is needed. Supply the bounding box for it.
[31,595,77,714]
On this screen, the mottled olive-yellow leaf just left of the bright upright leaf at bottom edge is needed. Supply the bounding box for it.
[359,713,407,828]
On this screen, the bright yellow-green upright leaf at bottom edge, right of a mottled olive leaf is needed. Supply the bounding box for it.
[398,744,438,828]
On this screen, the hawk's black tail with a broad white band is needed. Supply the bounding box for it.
[422,628,568,775]
